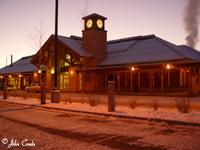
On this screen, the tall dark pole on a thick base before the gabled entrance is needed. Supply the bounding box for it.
[51,0,60,103]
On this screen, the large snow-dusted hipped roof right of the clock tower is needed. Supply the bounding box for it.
[100,35,200,66]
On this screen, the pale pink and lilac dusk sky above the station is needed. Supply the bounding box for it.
[0,0,200,67]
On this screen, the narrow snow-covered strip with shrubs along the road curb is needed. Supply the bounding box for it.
[0,97,200,123]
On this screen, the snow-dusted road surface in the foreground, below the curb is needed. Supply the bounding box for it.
[0,102,200,150]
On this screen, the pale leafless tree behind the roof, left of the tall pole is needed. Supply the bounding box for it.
[26,21,46,50]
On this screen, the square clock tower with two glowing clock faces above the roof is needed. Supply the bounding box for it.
[82,14,107,67]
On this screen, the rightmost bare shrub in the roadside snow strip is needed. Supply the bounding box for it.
[175,97,190,113]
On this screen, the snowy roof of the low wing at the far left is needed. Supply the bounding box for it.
[0,55,35,74]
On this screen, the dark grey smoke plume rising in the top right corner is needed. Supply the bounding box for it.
[183,0,200,48]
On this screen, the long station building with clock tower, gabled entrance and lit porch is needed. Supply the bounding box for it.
[0,14,200,94]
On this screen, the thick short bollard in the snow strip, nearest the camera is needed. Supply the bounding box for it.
[108,81,115,112]
